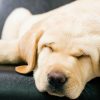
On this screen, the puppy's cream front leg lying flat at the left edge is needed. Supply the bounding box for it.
[0,40,22,64]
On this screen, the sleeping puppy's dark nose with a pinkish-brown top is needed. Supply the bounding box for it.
[48,72,67,88]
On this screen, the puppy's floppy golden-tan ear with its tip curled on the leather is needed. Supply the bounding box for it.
[15,31,43,74]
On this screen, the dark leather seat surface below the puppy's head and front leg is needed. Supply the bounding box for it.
[0,65,100,100]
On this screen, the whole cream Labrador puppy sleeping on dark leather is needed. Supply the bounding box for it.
[0,0,100,99]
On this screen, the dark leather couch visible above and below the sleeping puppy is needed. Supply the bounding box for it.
[0,0,100,100]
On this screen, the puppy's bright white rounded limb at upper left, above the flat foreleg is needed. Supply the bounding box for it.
[1,8,32,40]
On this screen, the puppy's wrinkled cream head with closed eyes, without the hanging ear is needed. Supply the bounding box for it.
[16,31,98,99]
